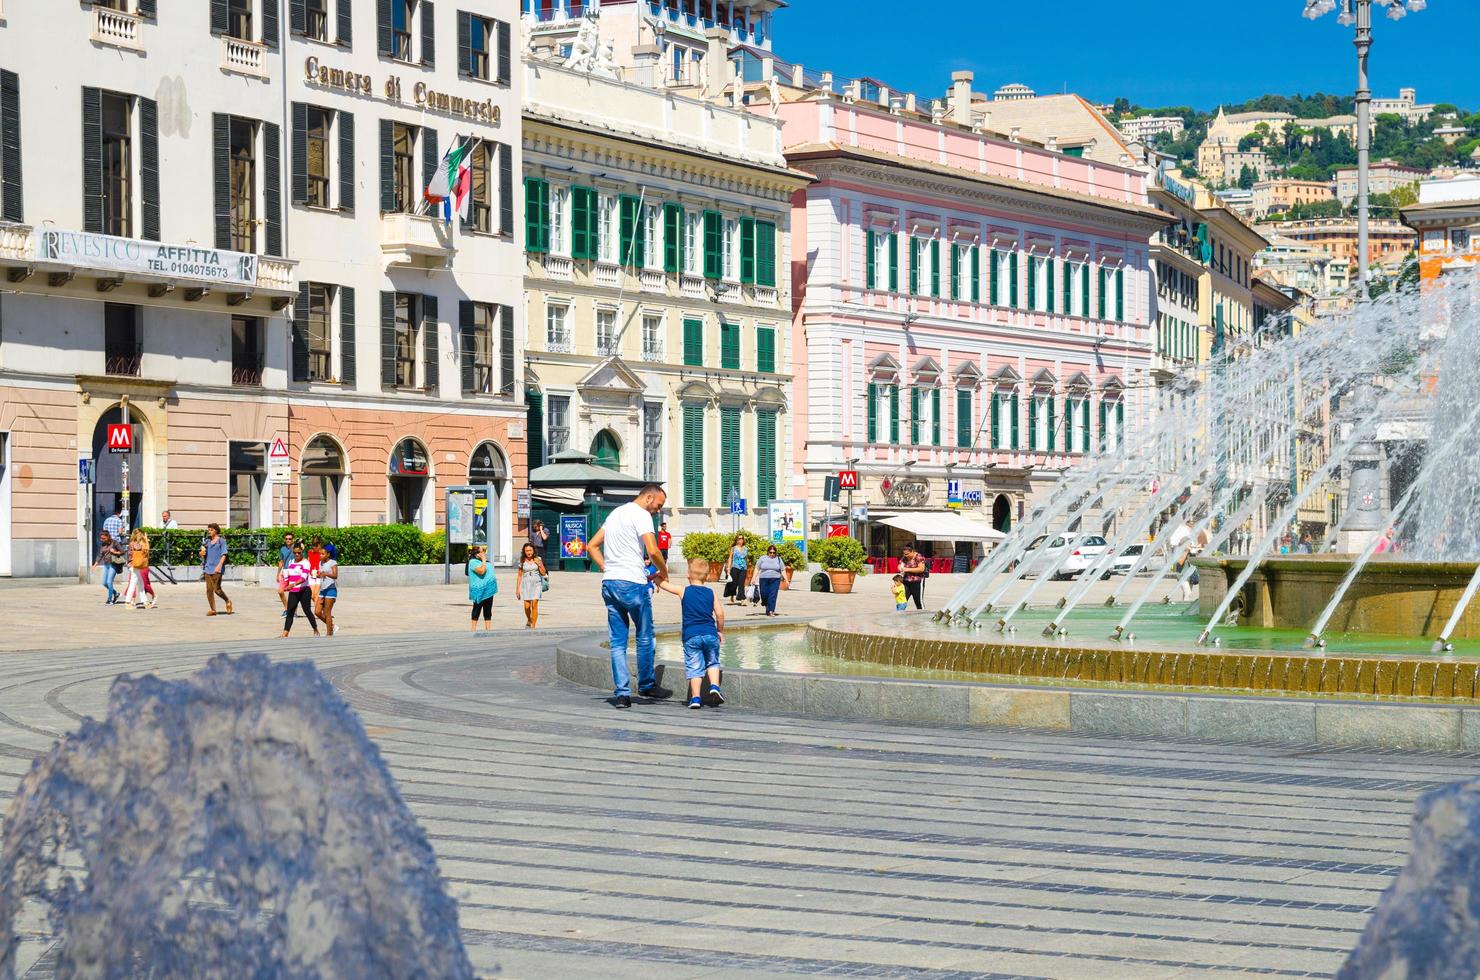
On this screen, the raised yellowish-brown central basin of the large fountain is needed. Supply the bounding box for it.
[1193,555,1480,640]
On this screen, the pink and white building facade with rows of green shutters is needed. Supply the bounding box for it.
[781,92,1163,557]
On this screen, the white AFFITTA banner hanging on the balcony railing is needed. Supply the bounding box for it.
[36,229,258,287]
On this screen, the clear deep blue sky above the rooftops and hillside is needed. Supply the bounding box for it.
[774,0,1480,111]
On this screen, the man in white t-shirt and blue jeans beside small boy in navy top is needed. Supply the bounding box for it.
[586,484,673,708]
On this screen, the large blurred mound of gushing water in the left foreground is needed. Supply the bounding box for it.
[0,654,472,980]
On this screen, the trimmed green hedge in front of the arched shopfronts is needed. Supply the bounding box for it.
[144,524,468,565]
